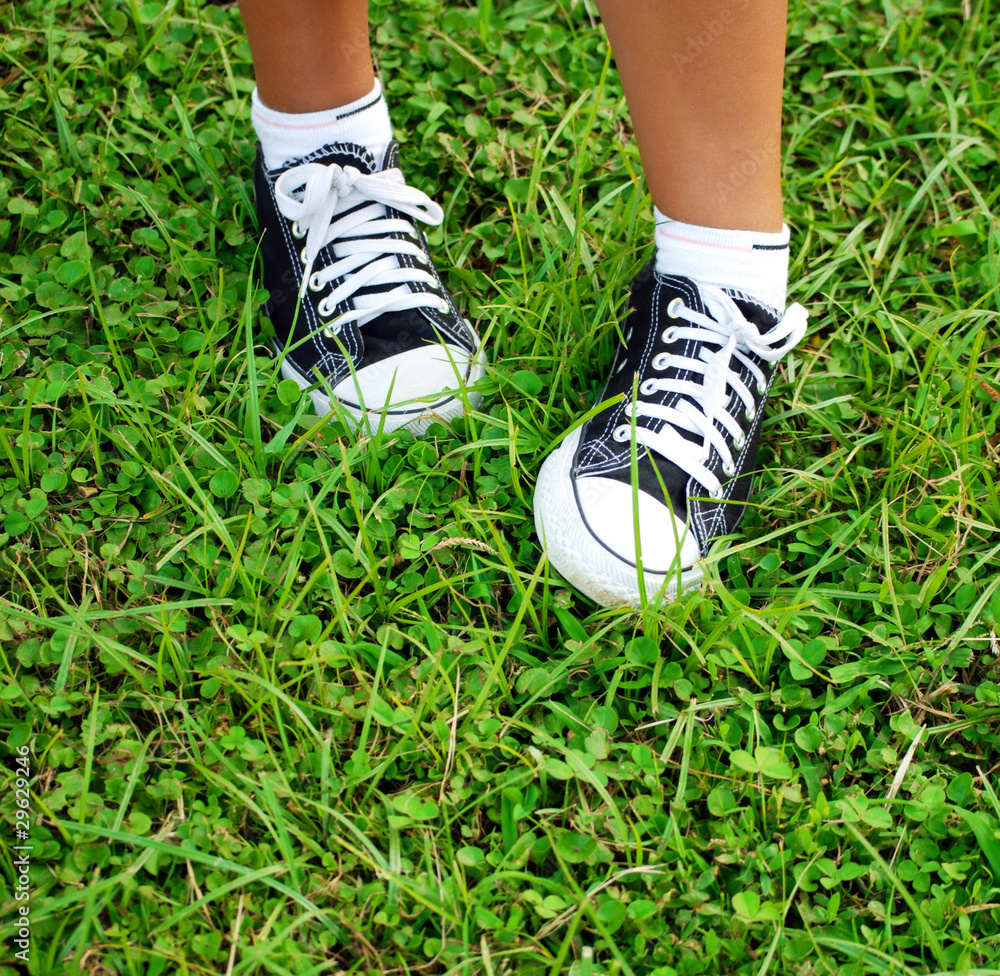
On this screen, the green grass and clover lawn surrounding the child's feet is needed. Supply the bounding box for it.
[0,0,1000,976]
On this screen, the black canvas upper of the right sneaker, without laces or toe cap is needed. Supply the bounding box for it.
[573,262,777,552]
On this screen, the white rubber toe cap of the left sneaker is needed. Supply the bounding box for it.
[333,344,472,411]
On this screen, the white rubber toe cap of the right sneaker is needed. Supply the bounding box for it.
[576,478,701,575]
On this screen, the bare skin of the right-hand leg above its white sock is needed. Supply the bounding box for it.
[597,0,787,232]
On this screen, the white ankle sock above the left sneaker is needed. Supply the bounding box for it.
[253,78,392,169]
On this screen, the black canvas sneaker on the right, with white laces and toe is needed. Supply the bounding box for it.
[535,263,807,606]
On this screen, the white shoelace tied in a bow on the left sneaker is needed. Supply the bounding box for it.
[274,163,448,336]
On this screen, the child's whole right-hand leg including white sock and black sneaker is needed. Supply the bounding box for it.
[535,0,805,605]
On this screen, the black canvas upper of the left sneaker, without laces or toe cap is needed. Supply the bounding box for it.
[254,142,476,385]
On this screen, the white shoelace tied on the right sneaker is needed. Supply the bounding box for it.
[614,288,809,499]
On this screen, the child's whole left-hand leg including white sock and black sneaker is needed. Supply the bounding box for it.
[240,0,483,433]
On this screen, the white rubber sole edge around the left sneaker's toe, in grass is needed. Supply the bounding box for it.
[279,326,487,436]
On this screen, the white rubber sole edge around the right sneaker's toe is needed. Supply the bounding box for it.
[535,428,705,607]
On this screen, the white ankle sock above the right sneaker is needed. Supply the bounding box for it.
[653,207,789,315]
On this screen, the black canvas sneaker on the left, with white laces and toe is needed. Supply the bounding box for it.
[254,142,485,433]
